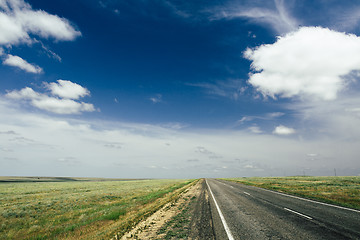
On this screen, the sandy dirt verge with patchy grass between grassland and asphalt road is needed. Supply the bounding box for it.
[113,179,215,240]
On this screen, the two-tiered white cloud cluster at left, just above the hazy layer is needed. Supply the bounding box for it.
[6,80,95,114]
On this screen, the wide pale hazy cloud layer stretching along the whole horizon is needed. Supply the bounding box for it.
[0,93,360,178]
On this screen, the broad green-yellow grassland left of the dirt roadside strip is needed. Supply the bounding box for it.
[0,177,192,239]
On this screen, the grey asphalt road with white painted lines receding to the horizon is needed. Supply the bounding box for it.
[206,179,360,240]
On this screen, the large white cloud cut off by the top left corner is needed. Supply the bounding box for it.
[0,0,81,45]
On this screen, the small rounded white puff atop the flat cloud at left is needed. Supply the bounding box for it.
[47,79,90,99]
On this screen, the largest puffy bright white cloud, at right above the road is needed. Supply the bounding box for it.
[244,27,360,100]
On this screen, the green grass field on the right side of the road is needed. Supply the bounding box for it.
[224,176,360,209]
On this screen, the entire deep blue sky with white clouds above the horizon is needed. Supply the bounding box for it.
[0,0,360,178]
